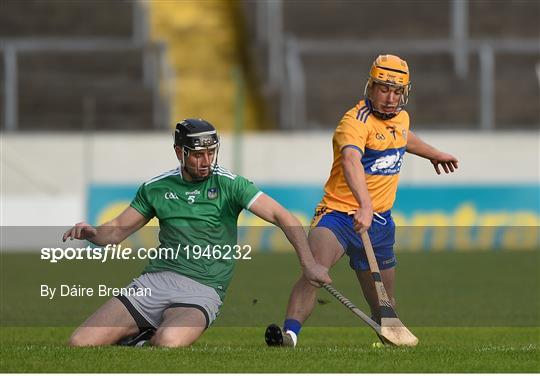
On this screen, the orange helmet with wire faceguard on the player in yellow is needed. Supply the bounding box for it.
[364,55,411,120]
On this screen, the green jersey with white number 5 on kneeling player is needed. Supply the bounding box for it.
[131,166,261,299]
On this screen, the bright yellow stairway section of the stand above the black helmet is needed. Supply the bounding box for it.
[148,0,267,130]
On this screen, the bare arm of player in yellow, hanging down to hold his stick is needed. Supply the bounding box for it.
[341,148,373,232]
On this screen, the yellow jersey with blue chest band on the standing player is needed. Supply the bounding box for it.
[317,100,409,213]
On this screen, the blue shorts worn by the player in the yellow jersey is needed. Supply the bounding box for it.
[315,210,396,271]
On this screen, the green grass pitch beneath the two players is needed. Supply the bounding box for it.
[0,252,540,373]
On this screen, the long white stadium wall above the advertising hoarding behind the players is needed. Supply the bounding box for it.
[1,132,540,226]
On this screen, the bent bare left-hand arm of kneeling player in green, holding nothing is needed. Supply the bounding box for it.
[62,207,149,245]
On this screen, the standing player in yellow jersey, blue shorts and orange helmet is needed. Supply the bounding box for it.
[265,55,458,346]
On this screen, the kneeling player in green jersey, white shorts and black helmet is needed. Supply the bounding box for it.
[63,119,331,347]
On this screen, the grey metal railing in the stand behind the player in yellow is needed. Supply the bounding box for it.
[256,0,540,131]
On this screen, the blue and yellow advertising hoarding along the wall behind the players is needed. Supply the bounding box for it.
[87,184,540,251]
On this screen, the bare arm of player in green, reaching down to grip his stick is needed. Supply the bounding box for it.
[249,193,332,287]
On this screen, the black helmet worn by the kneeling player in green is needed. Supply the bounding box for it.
[174,119,219,154]
